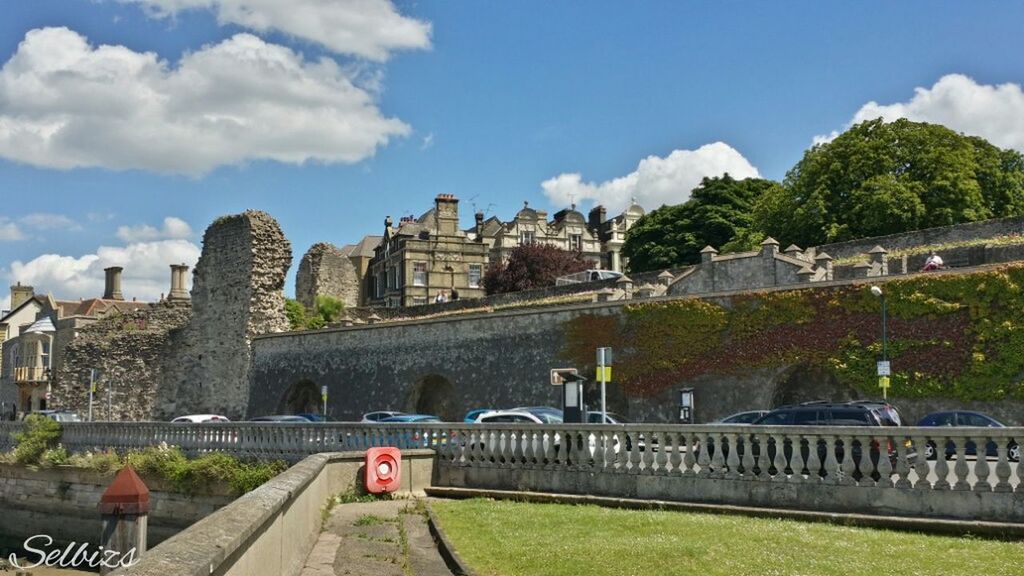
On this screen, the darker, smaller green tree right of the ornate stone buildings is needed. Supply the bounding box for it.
[623,174,780,272]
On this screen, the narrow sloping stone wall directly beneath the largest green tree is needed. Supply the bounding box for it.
[808,216,1024,259]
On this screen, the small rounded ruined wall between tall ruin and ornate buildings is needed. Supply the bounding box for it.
[295,242,359,308]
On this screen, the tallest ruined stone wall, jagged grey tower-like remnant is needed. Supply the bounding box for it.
[155,210,292,419]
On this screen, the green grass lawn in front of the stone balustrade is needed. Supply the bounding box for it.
[433,499,1024,576]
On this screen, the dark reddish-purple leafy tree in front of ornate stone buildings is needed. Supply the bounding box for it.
[483,244,592,294]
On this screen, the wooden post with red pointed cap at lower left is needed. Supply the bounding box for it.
[99,465,150,574]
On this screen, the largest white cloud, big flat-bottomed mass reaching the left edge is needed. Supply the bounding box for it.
[0,28,410,175]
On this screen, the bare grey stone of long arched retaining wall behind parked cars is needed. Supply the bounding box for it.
[249,266,1024,425]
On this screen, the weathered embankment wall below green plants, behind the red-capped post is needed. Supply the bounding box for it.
[0,464,233,548]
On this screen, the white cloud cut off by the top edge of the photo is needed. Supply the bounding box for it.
[121,0,431,61]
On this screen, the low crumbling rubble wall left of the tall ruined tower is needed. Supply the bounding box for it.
[50,303,191,420]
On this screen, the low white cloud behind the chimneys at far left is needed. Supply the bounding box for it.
[7,240,200,301]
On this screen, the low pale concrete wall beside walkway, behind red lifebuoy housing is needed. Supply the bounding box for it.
[114,450,434,576]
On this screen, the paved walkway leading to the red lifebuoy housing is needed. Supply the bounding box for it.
[302,500,452,576]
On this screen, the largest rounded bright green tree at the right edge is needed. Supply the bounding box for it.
[753,119,1024,247]
